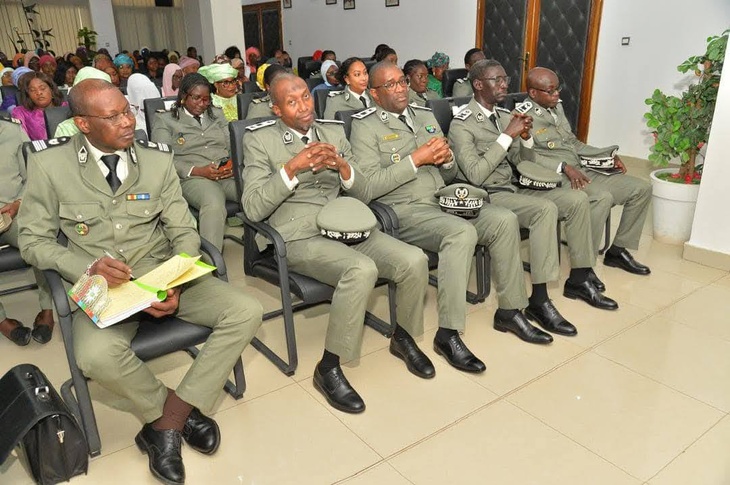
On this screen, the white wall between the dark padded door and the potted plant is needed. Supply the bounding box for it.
[588,0,730,158]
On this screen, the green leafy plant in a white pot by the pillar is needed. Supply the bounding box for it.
[644,30,730,243]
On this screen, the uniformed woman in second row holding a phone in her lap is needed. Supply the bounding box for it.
[151,73,238,250]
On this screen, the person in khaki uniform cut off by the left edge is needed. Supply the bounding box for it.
[0,116,53,346]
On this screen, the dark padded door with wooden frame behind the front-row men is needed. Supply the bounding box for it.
[477,0,603,141]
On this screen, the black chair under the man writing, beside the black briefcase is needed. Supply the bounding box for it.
[44,239,246,456]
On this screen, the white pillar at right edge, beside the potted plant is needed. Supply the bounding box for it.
[688,45,730,254]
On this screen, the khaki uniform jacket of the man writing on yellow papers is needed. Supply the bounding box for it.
[18,134,200,281]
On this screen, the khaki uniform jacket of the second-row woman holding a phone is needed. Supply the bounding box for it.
[150,107,231,179]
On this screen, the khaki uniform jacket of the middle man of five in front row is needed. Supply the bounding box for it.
[350,106,458,207]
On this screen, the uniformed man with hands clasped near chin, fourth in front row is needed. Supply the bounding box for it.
[449,60,618,326]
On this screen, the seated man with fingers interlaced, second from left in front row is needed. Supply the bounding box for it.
[242,74,435,413]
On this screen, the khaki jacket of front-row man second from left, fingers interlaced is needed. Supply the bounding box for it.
[241,120,369,242]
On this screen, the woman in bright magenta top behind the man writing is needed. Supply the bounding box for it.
[13,72,67,140]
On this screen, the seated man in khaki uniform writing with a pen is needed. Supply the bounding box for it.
[18,79,262,483]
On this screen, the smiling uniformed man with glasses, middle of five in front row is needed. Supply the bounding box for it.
[350,62,552,372]
